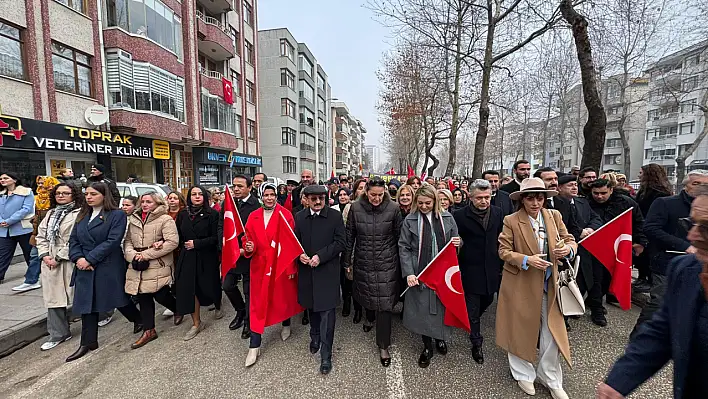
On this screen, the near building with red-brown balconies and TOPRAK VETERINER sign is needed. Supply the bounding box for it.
[0,0,261,195]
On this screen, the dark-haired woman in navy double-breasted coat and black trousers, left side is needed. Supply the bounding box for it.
[66,182,143,362]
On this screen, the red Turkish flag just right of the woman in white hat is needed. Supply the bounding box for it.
[578,208,632,310]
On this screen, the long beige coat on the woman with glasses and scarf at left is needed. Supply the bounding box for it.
[36,209,79,308]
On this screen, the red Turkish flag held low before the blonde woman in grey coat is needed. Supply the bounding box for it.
[418,242,470,332]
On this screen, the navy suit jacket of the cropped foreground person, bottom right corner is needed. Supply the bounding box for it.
[606,255,707,399]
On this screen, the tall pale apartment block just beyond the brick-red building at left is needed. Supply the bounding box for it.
[258,28,332,181]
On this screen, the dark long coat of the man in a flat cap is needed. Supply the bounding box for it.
[295,207,346,312]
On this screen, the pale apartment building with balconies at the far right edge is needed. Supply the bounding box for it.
[644,40,708,177]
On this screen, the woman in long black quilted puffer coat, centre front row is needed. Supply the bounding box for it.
[344,178,403,367]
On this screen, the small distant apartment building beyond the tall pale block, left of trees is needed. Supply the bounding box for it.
[332,101,366,176]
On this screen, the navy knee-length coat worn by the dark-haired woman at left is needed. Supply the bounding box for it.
[69,210,130,314]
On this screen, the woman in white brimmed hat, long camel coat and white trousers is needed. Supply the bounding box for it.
[496,178,577,399]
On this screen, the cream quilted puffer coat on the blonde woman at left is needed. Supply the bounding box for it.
[123,205,179,295]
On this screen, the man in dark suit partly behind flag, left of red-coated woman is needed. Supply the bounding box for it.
[217,175,261,339]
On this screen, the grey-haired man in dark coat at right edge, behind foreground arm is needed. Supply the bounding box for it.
[632,169,708,336]
